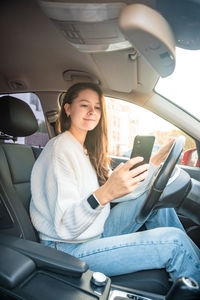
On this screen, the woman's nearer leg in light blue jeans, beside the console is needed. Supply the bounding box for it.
[54,227,200,284]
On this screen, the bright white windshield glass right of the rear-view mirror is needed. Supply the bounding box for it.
[155,48,200,120]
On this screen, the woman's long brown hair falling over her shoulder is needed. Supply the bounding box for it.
[56,82,110,185]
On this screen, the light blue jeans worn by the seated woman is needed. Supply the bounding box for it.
[42,194,200,284]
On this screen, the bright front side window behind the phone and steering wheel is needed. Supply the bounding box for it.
[105,97,197,166]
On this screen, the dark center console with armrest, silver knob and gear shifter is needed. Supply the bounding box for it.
[0,234,200,300]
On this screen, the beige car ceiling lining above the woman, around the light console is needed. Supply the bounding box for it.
[0,0,200,105]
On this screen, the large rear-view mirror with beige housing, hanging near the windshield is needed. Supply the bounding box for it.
[119,4,175,77]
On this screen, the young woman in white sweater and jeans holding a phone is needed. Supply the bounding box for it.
[30,83,200,284]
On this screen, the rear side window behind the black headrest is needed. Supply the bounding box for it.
[0,93,49,147]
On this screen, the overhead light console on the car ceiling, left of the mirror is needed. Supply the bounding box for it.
[39,0,131,52]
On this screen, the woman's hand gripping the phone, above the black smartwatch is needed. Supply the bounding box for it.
[94,157,149,205]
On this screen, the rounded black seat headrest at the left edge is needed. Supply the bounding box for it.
[0,96,38,137]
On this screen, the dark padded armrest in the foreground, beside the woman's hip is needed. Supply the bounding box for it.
[0,234,88,277]
